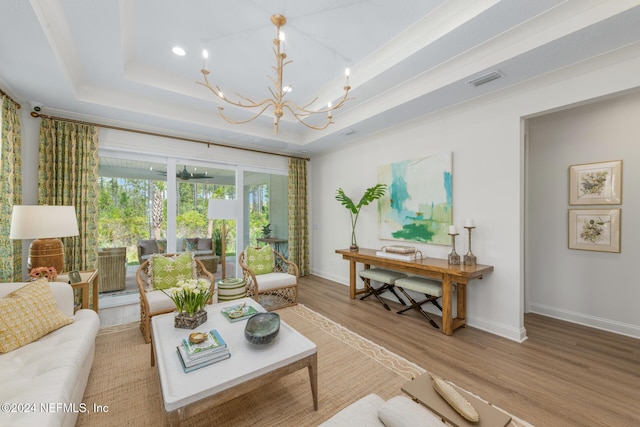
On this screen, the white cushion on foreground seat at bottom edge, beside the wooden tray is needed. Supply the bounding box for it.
[378,396,445,427]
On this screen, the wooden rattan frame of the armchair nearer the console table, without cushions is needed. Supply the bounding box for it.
[238,248,300,311]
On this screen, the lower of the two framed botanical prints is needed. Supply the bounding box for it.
[569,209,621,253]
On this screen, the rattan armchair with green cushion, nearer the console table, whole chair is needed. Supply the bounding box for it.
[238,246,299,311]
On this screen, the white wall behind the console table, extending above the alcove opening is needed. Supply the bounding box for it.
[310,41,640,341]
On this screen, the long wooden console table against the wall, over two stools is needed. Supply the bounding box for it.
[336,248,493,335]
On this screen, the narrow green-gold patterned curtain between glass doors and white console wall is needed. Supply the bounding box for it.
[289,158,309,276]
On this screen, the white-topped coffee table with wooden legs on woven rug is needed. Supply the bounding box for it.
[151,298,318,425]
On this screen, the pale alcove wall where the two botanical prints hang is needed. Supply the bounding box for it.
[526,93,640,338]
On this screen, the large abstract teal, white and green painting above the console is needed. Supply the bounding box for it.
[378,152,453,245]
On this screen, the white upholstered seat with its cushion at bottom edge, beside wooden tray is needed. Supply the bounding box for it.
[320,393,445,427]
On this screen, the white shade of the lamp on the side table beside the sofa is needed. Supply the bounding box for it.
[9,205,80,239]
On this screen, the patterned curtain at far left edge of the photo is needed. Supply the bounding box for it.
[0,96,23,282]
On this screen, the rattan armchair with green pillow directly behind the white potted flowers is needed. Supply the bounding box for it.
[136,252,215,344]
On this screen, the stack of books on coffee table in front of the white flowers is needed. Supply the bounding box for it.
[177,329,231,372]
